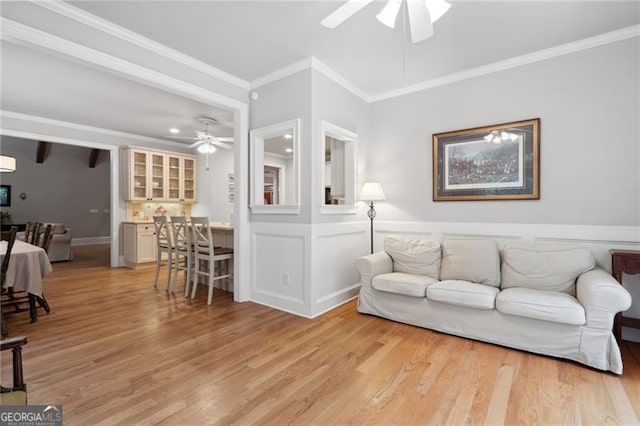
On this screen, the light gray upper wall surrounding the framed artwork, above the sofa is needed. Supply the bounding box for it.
[364,38,640,226]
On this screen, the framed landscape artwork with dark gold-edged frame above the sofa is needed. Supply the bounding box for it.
[433,118,540,201]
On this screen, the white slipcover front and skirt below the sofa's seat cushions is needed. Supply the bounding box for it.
[358,285,622,374]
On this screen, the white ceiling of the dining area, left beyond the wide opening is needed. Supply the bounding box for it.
[0,42,233,144]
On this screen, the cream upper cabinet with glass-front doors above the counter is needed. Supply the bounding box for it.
[124,148,196,203]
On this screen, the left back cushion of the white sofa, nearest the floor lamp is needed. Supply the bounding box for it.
[384,236,441,280]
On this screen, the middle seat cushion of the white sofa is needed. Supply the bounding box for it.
[427,280,500,309]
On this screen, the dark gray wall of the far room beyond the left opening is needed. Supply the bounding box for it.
[0,136,111,238]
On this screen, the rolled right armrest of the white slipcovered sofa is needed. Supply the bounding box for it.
[576,268,631,330]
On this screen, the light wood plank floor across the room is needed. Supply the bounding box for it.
[2,246,640,425]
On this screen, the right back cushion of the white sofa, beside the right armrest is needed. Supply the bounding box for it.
[501,247,595,296]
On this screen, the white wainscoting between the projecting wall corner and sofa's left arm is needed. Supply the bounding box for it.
[311,222,369,317]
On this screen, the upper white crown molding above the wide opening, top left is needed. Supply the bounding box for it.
[29,0,249,90]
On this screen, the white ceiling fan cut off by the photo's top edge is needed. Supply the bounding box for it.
[321,0,451,43]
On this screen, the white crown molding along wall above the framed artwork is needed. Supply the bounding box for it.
[369,25,640,102]
